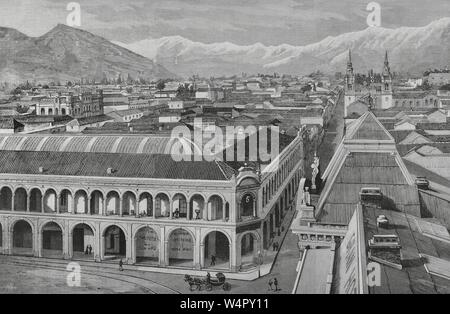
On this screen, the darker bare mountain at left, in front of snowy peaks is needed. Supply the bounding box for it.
[0,24,176,82]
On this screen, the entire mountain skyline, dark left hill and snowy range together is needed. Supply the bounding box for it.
[0,17,450,82]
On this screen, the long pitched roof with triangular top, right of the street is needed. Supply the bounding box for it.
[316,112,414,225]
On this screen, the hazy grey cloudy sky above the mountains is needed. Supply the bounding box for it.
[0,0,450,45]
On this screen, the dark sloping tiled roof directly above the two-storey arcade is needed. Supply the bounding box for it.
[0,151,235,181]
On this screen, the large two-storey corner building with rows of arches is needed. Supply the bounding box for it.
[0,133,304,272]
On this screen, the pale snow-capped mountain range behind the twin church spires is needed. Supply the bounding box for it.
[117,17,450,76]
